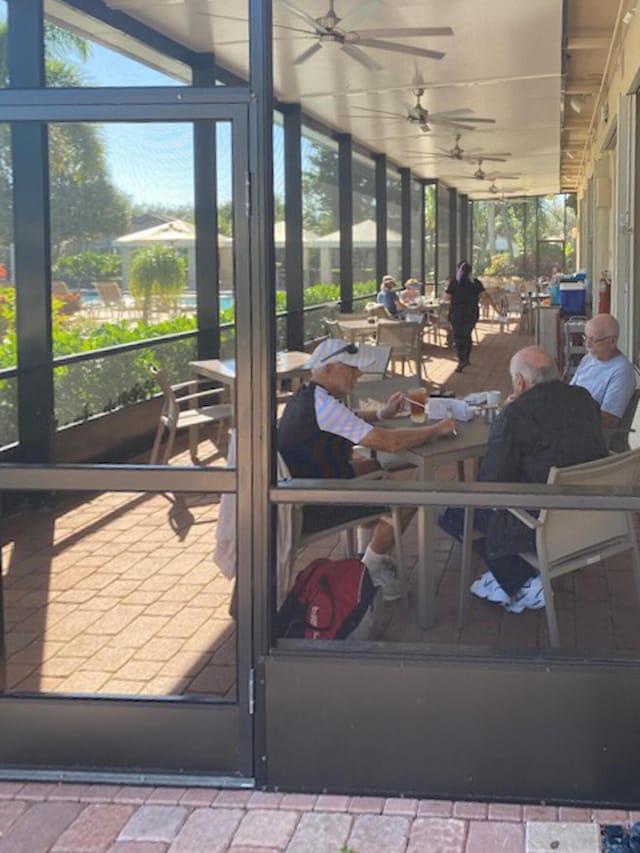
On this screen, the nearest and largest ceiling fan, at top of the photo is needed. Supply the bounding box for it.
[276,0,453,71]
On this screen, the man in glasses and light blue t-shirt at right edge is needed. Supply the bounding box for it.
[571,314,636,427]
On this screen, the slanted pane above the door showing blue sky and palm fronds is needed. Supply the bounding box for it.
[45,2,191,88]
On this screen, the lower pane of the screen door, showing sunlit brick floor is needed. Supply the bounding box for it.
[2,492,237,699]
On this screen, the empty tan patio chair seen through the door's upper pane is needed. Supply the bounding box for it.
[149,365,233,465]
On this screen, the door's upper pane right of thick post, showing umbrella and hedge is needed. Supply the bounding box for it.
[49,122,235,465]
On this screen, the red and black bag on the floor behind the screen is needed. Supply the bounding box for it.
[276,557,378,640]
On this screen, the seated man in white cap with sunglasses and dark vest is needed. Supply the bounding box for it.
[278,339,455,600]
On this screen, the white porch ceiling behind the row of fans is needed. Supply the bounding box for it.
[67,0,606,198]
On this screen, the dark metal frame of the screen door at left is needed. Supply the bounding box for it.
[0,96,254,787]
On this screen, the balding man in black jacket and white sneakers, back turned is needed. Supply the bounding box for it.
[439,347,607,613]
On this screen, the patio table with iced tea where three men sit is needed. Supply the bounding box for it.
[380,417,489,628]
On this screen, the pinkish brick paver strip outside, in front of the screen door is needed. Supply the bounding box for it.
[0,782,624,853]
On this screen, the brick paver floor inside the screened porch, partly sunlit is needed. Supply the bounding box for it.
[2,321,640,704]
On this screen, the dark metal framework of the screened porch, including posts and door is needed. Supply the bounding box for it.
[0,0,640,804]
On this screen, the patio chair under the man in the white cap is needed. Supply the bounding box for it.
[277,453,408,606]
